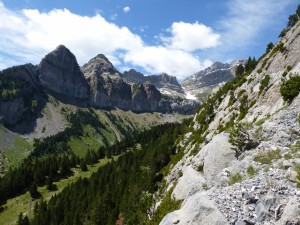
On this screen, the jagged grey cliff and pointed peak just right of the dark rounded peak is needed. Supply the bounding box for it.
[82,55,160,112]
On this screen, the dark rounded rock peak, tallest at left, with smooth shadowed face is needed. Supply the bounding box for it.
[38,45,89,100]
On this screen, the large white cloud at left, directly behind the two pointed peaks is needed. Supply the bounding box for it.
[0,4,144,64]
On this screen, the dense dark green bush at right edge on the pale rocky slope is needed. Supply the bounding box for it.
[280,75,300,102]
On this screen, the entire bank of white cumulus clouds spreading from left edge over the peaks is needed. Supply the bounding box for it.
[0,1,218,79]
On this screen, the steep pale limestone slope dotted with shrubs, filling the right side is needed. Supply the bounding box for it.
[160,22,300,225]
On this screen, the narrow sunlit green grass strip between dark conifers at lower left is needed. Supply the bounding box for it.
[0,156,118,225]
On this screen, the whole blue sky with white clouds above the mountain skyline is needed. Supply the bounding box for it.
[0,0,299,80]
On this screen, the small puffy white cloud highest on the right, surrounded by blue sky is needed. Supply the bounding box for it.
[161,22,220,52]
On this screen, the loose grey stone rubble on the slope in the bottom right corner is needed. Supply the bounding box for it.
[208,169,300,225]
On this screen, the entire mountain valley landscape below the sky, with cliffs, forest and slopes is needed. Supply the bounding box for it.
[0,4,300,225]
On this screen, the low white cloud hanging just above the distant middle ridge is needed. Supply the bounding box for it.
[124,46,212,80]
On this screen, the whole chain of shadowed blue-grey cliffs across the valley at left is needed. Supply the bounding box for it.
[0,45,199,126]
